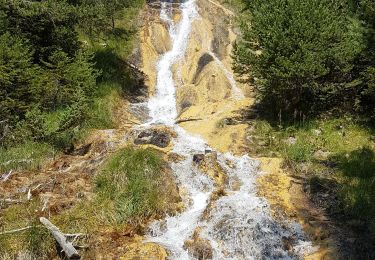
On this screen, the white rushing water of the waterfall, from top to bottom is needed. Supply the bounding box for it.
[145,0,311,260]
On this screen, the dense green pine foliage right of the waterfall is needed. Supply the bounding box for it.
[234,0,365,117]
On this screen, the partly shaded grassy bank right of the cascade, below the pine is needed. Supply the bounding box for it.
[251,117,375,241]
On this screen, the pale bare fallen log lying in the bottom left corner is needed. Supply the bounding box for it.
[39,217,81,259]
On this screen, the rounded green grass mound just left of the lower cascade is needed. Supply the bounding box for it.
[95,148,164,223]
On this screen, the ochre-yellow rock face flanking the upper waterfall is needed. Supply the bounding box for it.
[139,0,254,154]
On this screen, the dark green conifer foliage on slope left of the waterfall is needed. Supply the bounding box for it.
[0,0,144,152]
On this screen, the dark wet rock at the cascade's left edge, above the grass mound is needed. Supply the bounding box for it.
[134,129,171,148]
